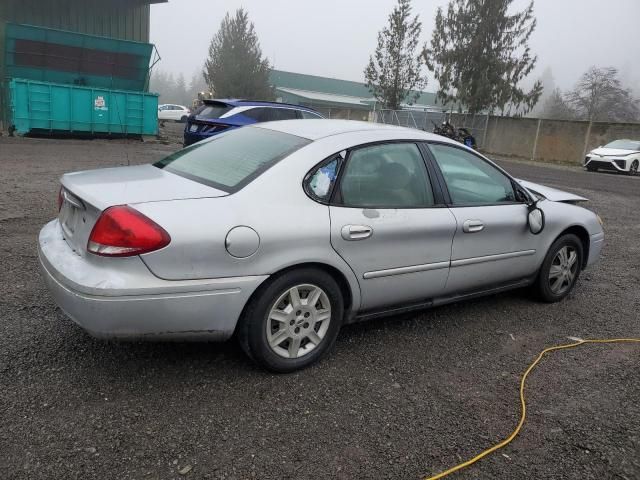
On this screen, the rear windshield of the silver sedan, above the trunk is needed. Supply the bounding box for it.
[154,127,310,193]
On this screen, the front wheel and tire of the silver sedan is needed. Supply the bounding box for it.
[535,234,583,303]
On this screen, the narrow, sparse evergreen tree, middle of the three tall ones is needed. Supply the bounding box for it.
[364,0,427,110]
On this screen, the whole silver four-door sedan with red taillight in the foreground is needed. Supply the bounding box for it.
[39,120,604,372]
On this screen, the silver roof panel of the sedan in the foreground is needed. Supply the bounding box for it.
[252,119,447,141]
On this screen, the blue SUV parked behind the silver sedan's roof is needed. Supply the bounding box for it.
[184,99,324,147]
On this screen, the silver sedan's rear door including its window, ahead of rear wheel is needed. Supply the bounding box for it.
[314,142,455,310]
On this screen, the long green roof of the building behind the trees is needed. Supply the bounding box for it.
[271,70,437,106]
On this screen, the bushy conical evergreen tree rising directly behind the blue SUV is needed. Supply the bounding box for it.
[203,8,274,100]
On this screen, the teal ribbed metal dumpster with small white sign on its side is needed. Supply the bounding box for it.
[9,78,158,136]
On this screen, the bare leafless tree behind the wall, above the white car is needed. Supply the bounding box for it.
[567,67,640,122]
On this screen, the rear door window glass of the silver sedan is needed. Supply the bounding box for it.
[340,143,434,208]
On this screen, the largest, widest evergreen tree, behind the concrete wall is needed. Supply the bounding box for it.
[423,0,542,113]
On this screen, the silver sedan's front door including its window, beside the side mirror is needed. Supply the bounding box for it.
[429,143,541,294]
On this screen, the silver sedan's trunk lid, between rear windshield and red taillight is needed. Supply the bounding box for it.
[58,165,228,256]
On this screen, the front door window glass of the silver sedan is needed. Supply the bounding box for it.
[429,144,516,205]
